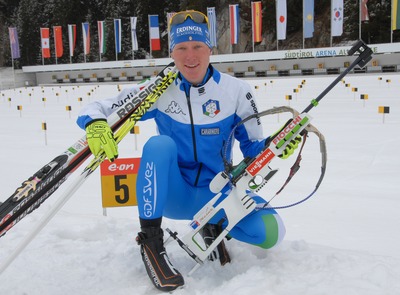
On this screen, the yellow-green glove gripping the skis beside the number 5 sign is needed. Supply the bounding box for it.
[86,120,118,162]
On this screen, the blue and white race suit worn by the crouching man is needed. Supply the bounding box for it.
[77,66,285,248]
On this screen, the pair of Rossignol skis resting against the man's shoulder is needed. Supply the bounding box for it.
[0,63,177,237]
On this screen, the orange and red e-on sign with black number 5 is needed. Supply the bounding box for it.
[100,158,140,208]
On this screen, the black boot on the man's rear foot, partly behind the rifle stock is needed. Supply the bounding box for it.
[201,223,231,265]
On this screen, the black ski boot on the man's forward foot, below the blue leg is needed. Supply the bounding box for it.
[136,227,185,291]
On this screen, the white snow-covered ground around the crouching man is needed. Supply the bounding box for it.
[0,70,400,295]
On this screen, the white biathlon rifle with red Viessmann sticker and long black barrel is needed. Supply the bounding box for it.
[166,41,372,274]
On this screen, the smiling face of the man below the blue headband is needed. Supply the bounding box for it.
[171,41,211,85]
